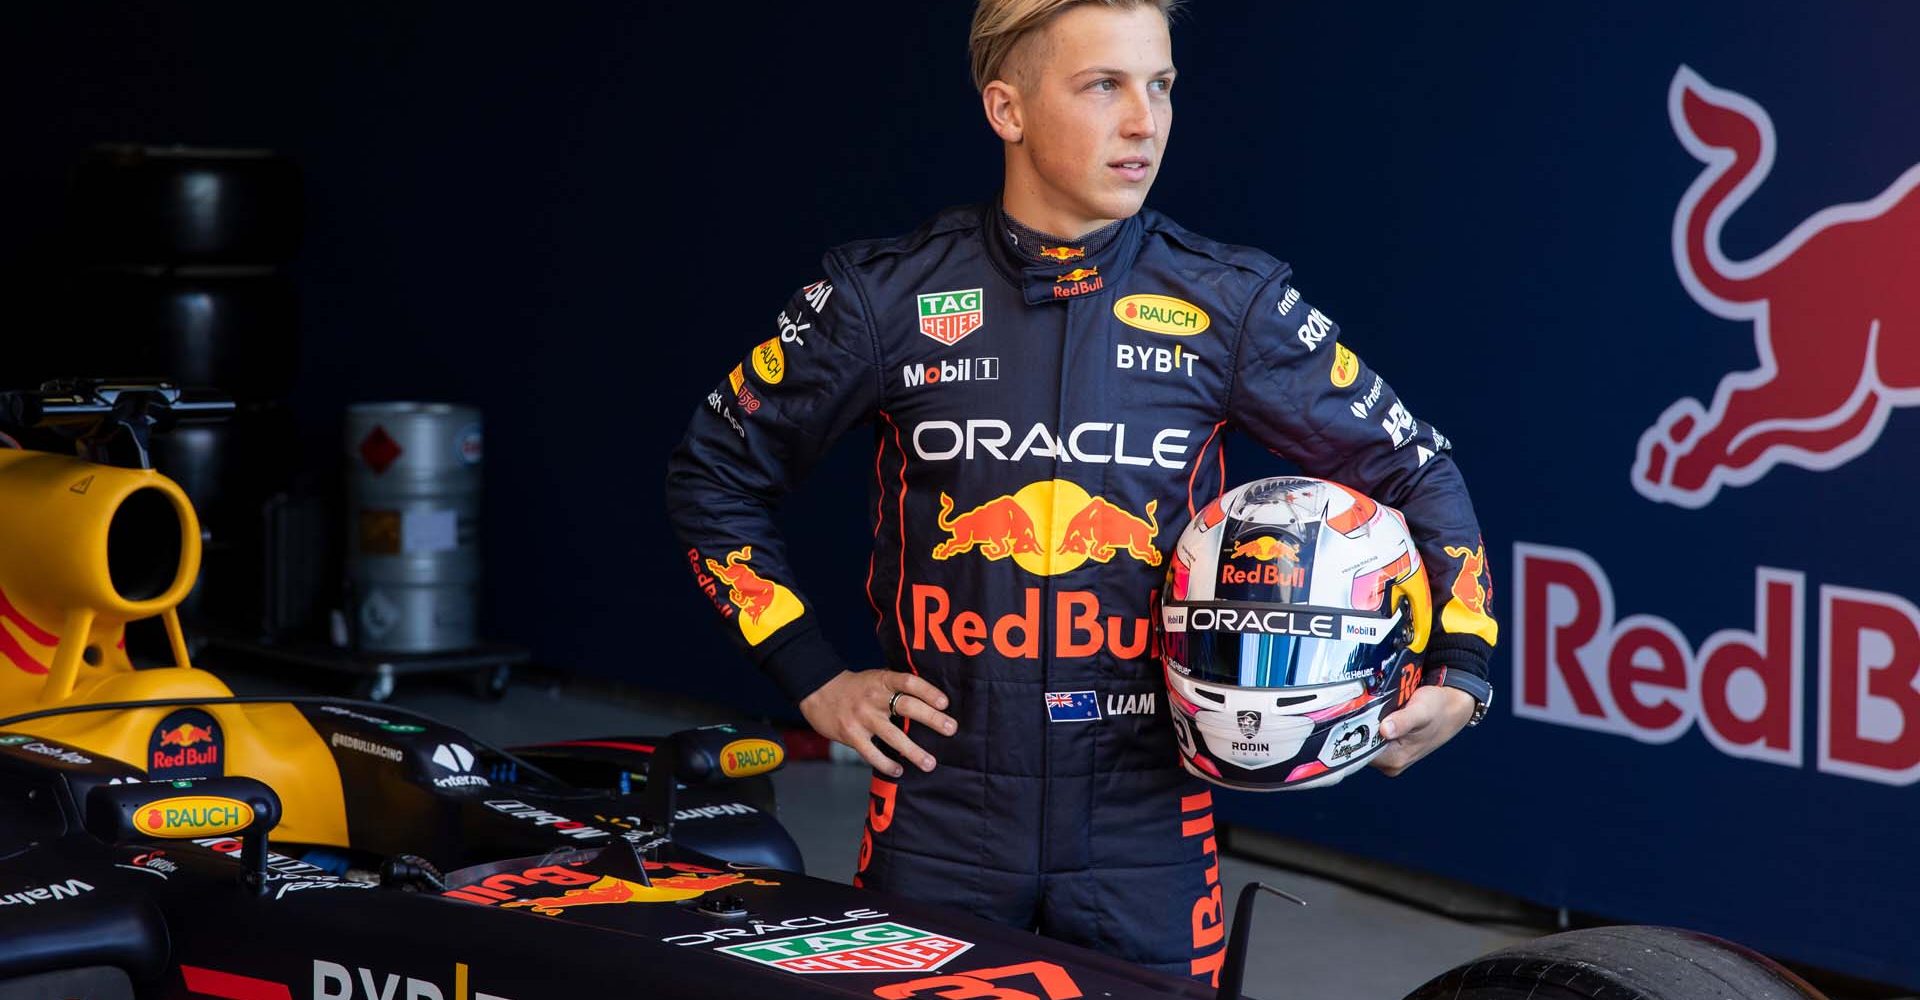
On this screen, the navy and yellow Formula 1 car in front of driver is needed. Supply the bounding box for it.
[0,384,1818,1000]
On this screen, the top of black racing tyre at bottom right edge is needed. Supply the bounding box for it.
[1405,925,1826,1000]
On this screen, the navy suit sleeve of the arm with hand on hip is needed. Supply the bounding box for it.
[666,257,879,702]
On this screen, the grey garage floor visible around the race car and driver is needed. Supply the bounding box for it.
[221,670,1532,1000]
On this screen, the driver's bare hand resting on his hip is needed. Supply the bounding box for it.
[801,670,960,777]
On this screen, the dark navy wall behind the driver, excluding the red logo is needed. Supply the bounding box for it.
[0,0,1920,985]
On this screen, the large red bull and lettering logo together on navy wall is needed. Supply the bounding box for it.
[1512,67,1920,785]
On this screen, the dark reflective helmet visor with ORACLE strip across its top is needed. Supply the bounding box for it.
[1164,605,1404,691]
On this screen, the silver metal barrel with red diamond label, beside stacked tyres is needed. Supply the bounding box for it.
[346,403,482,653]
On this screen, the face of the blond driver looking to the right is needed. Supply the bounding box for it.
[1014,4,1173,219]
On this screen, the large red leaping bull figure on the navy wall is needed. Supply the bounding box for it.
[1632,65,1920,509]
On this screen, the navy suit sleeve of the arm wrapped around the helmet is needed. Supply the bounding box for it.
[1227,273,1500,679]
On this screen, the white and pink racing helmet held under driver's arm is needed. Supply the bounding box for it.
[1160,476,1432,791]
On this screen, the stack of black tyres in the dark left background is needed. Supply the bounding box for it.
[63,146,319,648]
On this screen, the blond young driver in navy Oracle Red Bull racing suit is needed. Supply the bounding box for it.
[668,0,1496,979]
